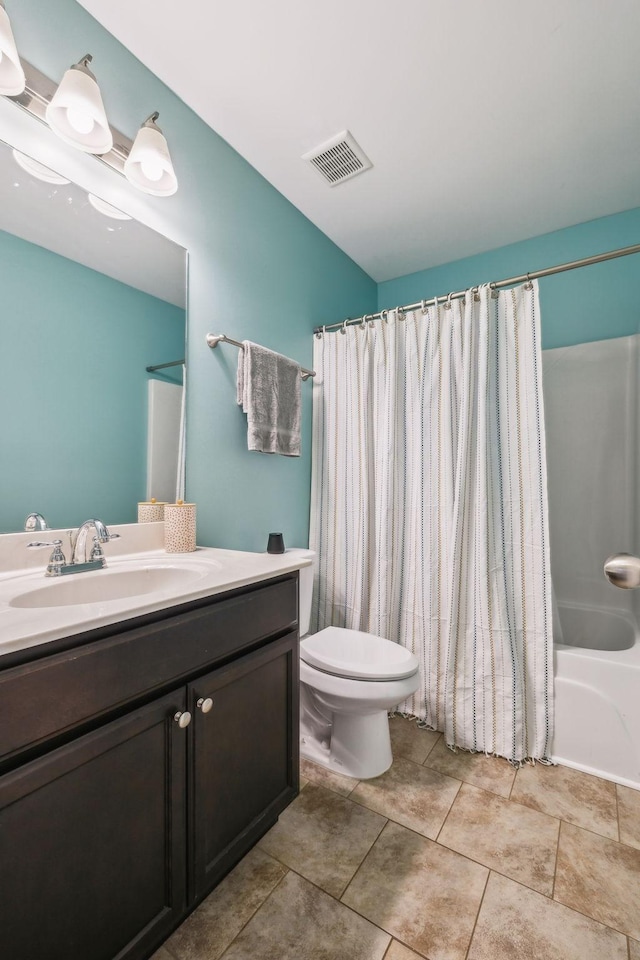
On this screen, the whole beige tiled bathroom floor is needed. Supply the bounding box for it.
[152,718,640,960]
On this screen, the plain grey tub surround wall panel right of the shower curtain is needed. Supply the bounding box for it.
[542,340,640,616]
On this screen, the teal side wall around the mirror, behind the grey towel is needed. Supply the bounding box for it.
[0,0,377,550]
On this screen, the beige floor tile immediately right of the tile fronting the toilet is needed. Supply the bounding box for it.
[438,783,560,896]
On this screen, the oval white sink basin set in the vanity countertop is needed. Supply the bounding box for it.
[9,562,210,609]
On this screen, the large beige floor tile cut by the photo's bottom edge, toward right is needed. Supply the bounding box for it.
[468,873,627,960]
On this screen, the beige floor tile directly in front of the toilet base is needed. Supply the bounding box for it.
[351,757,460,840]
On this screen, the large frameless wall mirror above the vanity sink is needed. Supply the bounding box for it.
[0,141,186,533]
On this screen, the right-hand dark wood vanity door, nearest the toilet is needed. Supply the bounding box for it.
[188,634,299,899]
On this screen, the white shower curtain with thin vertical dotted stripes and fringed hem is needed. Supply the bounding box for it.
[311,283,553,763]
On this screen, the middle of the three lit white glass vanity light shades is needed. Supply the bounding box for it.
[45,55,113,154]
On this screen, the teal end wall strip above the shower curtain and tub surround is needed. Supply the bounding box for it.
[378,209,640,348]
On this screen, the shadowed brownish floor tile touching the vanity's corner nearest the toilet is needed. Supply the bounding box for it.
[260,783,386,897]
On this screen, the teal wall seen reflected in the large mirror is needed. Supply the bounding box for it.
[0,231,185,532]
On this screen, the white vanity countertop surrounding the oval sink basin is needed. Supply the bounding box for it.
[0,544,312,657]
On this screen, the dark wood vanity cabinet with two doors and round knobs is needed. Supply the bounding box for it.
[0,574,298,960]
